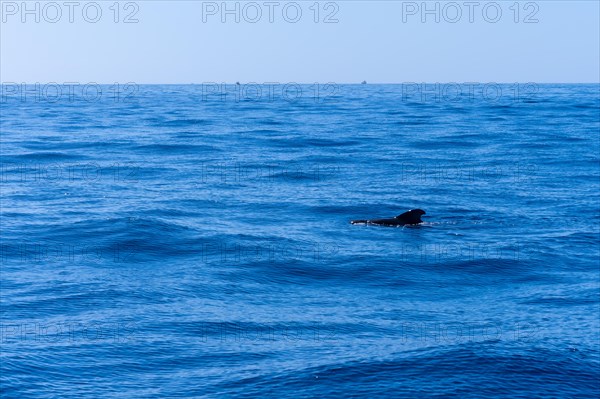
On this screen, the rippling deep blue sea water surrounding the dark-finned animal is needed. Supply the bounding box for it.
[0,84,600,398]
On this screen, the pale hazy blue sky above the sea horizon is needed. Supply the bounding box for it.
[0,0,600,84]
